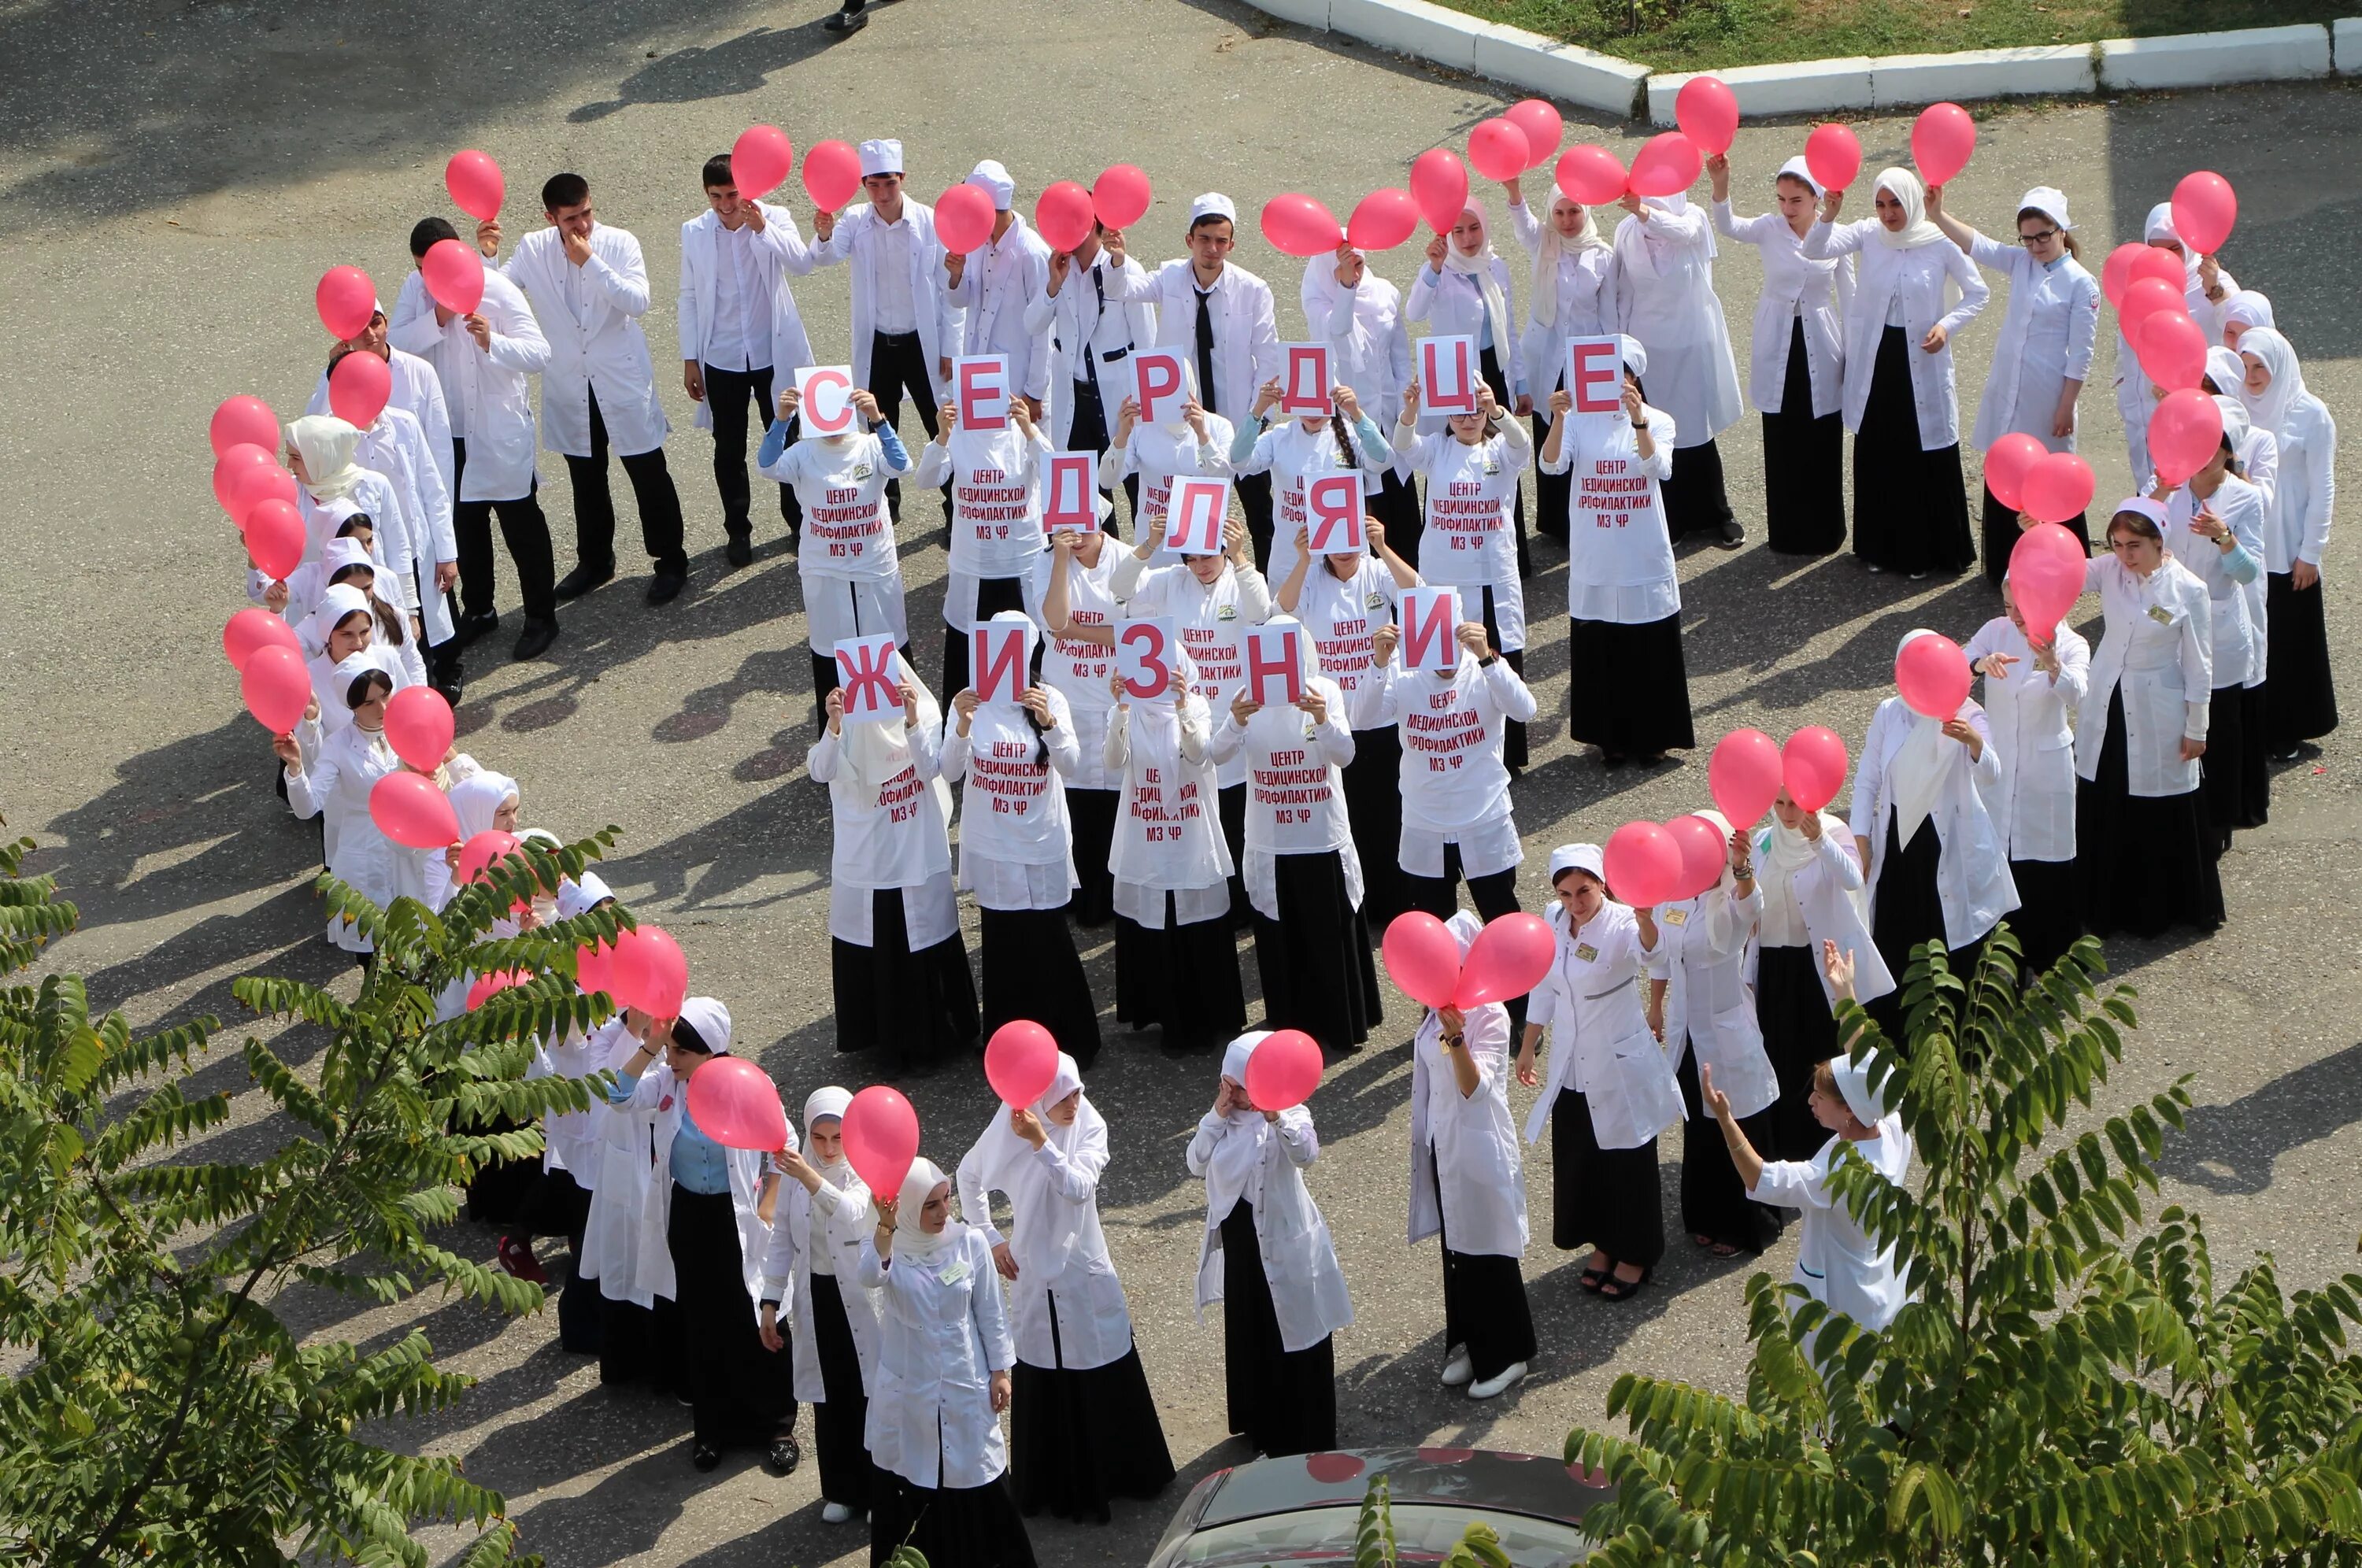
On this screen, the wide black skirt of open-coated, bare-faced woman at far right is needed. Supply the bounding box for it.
[2074,690,2223,937]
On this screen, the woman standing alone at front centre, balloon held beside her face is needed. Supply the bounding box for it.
[1188,1030,1353,1459]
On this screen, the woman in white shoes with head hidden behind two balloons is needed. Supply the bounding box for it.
[1410,909,1535,1400]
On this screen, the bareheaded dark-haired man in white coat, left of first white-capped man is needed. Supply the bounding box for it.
[680,153,820,567]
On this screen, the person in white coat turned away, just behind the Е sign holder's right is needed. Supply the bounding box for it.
[1616,196,1748,550]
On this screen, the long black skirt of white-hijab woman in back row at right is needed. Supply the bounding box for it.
[1854,326,1977,574]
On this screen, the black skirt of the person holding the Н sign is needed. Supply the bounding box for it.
[1254,850,1384,1051]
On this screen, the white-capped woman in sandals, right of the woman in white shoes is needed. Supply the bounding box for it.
[1516,843,1682,1301]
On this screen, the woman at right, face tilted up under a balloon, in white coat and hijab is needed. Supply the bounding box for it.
[1960,581,2090,980]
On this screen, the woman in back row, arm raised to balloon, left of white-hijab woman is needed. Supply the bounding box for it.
[1705,153,1854,557]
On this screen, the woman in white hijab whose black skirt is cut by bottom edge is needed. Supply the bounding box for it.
[853,1157,1035,1568]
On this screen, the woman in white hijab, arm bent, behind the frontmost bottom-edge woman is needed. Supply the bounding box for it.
[957,1051,1174,1523]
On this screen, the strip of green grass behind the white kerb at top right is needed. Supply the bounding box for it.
[1441,0,2355,71]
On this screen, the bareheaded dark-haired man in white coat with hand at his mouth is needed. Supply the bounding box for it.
[494,175,690,605]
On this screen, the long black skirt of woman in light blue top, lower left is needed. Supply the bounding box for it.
[664,1181,796,1448]
